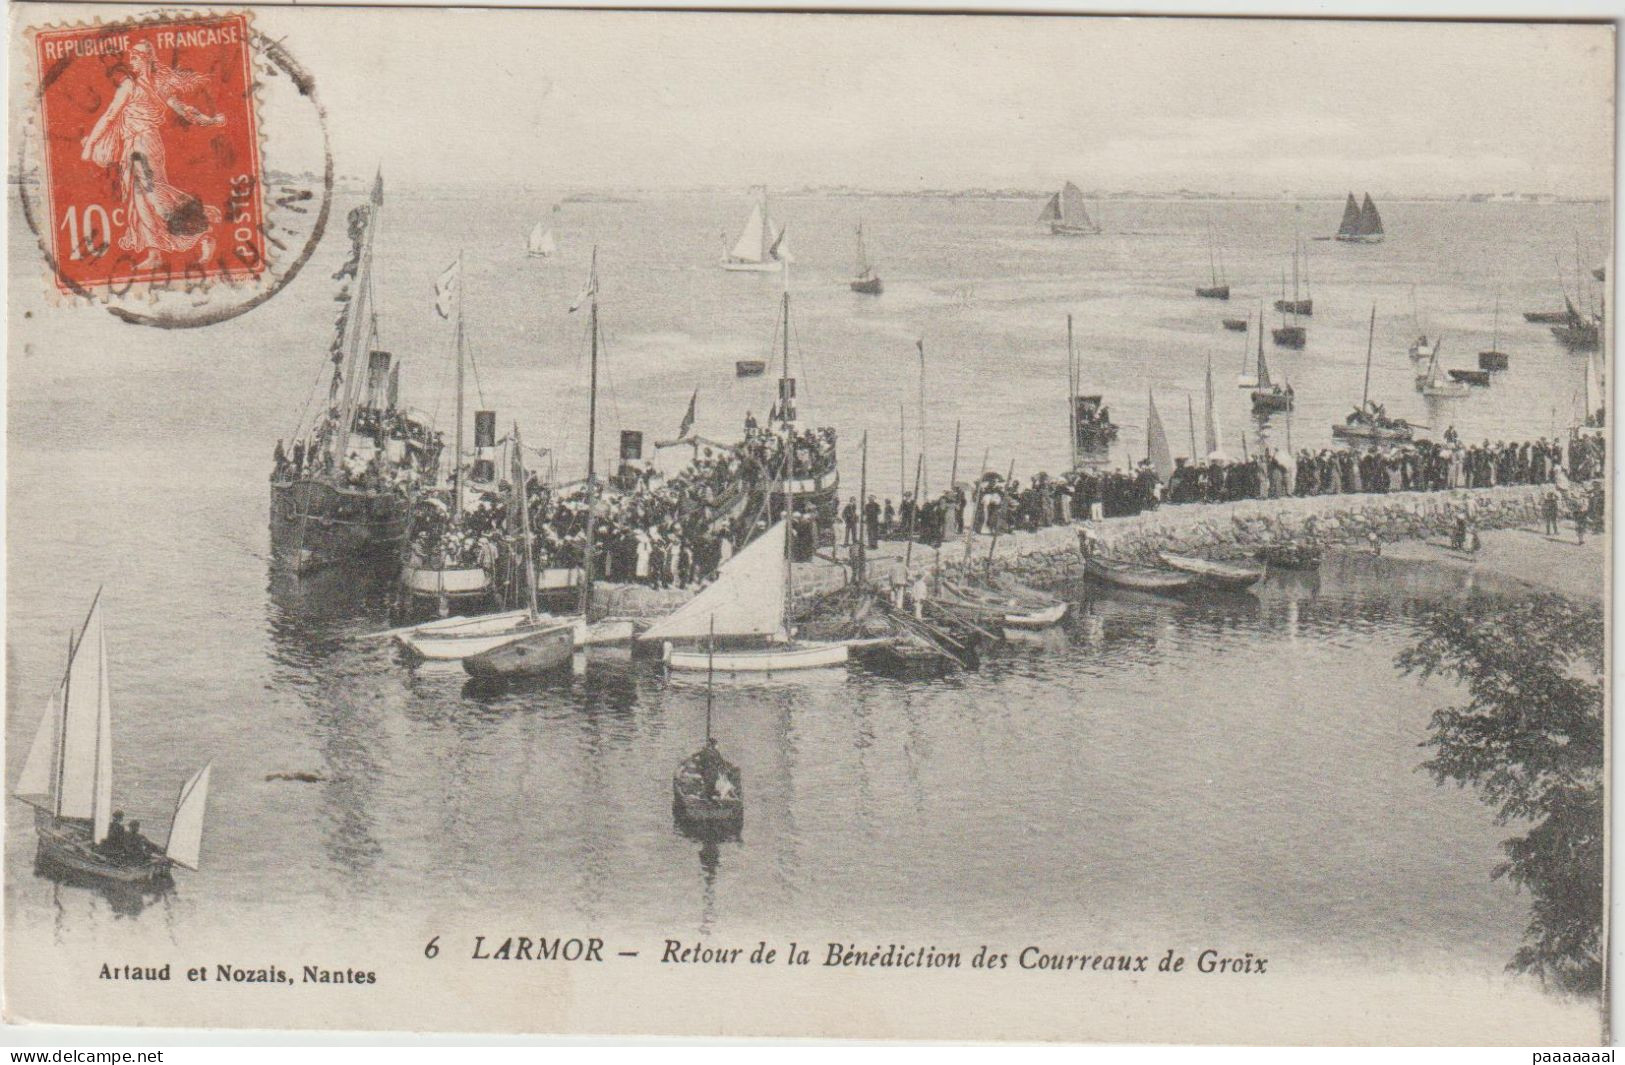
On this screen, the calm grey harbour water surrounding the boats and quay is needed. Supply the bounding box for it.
[5,190,1606,977]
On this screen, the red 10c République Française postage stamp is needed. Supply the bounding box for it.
[34,13,267,294]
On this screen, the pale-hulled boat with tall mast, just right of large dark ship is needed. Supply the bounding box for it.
[401,257,496,615]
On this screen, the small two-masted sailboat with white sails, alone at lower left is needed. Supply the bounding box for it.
[13,592,211,883]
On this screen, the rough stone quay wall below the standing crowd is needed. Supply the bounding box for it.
[593,485,1550,618]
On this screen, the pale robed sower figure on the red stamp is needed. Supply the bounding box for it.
[80,41,226,270]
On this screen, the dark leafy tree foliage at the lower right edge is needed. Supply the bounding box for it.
[1399,595,1606,993]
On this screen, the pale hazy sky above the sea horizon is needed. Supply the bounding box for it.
[9,8,1614,197]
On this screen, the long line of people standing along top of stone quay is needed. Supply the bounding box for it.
[842,429,1607,548]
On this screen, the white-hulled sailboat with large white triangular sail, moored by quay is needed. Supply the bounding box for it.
[642,285,848,673]
